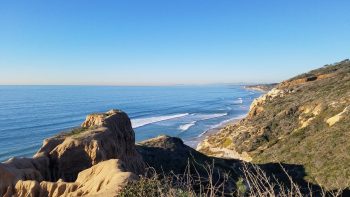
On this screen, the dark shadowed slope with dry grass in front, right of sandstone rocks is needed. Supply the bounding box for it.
[120,136,334,197]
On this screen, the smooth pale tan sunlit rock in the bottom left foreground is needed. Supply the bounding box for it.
[3,159,137,197]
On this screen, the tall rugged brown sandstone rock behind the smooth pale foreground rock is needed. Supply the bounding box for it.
[34,110,143,181]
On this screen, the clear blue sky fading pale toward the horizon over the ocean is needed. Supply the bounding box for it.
[0,0,350,85]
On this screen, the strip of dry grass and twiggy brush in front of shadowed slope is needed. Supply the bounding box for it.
[119,161,342,197]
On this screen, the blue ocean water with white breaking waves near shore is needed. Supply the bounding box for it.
[0,85,261,161]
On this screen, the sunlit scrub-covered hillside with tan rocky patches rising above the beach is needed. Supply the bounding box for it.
[197,60,350,189]
